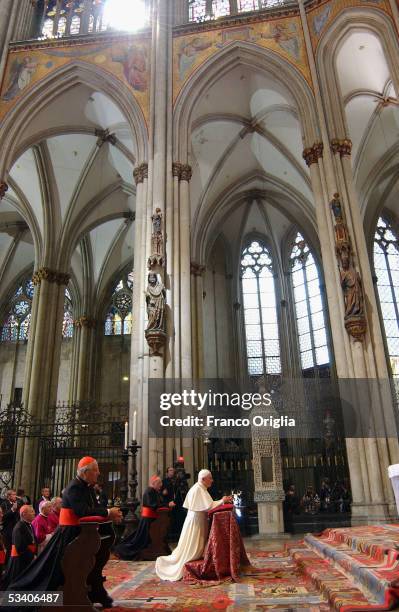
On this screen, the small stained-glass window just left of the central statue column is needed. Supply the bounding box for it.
[104,272,133,336]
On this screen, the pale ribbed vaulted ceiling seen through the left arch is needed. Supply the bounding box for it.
[0,85,135,310]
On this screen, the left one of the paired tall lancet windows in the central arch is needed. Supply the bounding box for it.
[241,240,281,377]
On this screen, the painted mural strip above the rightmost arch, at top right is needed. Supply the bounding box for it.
[307,0,391,49]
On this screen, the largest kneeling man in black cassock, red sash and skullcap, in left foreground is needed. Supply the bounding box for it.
[9,457,122,608]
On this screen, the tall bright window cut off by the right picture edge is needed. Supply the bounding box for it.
[374,217,399,378]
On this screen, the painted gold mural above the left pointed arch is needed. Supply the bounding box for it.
[0,37,150,122]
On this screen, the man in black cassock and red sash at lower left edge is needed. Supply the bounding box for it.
[1,505,37,590]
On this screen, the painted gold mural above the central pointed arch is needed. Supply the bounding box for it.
[173,17,311,100]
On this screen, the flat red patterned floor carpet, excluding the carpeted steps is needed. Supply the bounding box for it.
[106,549,331,612]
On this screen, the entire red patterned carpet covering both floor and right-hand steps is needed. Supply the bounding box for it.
[101,525,399,612]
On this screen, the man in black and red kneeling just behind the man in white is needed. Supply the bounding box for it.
[115,476,175,560]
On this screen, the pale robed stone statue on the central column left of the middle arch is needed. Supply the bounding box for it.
[145,272,166,355]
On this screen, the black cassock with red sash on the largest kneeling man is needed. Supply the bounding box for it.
[8,478,115,604]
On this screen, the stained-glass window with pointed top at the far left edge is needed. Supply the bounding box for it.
[1,279,34,342]
